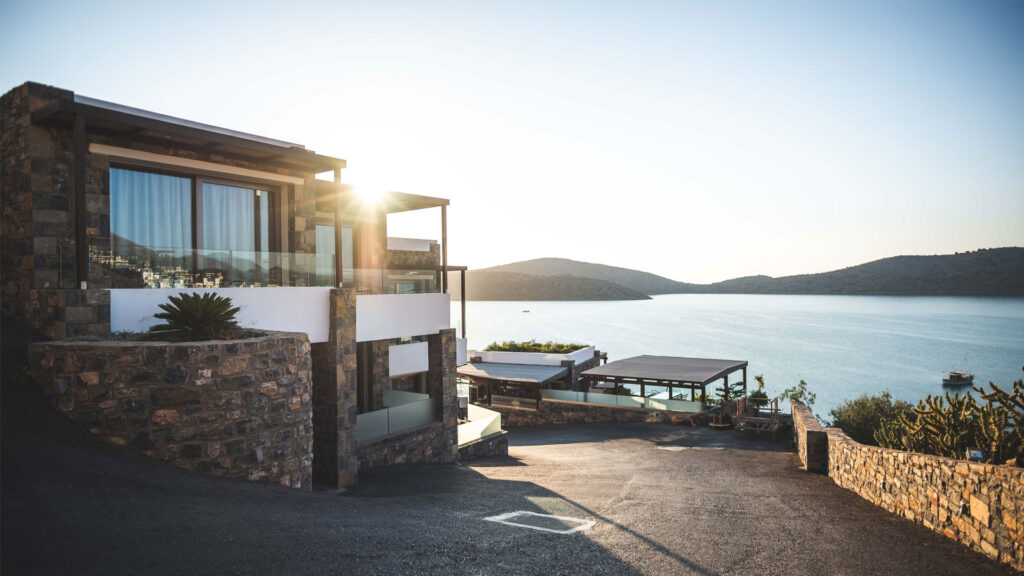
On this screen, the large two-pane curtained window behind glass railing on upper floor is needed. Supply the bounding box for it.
[107,168,296,288]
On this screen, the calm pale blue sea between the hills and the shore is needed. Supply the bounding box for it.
[452,294,1024,416]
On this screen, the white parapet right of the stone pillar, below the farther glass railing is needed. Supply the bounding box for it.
[355,293,452,342]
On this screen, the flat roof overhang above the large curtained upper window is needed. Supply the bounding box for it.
[32,95,346,173]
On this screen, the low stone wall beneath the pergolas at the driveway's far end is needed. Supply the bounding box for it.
[481,400,691,428]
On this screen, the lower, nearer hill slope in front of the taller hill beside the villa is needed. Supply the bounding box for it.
[449,269,650,300]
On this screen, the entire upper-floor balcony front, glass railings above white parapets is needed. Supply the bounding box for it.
[88,239,465,342]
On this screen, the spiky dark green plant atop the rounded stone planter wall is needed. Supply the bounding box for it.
[150,292,239,341]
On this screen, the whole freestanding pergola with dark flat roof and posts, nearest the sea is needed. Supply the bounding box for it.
[581,356,746,399]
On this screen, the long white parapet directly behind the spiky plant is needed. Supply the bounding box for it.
[111,287,331,342]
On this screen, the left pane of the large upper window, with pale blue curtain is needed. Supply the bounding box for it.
[109,168,193,288]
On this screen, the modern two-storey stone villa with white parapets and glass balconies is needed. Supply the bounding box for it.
[0,83,465,487]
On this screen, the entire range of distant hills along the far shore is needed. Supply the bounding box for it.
[453,248,1024,300]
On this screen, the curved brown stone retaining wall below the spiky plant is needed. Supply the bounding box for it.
[28,332,313,490]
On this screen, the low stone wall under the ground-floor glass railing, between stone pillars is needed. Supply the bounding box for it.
[358,422,458,469]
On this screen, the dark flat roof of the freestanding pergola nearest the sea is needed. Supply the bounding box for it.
[582,356,746,385]
